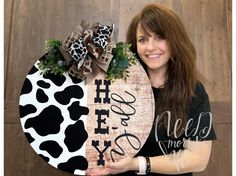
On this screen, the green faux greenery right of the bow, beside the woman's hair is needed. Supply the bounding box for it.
[107,42,137,82]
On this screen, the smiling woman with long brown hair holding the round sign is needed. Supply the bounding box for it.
[90,4,216,176]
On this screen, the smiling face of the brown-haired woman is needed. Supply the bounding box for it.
[136,27,171,71]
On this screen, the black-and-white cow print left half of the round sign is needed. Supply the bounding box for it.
[19,56,89,175]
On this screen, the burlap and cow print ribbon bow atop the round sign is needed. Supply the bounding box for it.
[60,21,115,80]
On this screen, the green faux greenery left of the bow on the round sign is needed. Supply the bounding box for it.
[38,39,69,75]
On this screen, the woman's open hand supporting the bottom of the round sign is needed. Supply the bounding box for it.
[88,157,138,176]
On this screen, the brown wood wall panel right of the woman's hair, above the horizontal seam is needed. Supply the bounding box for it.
[179,0,231,101]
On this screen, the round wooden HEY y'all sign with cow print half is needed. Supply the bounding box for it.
[19,57,154,175]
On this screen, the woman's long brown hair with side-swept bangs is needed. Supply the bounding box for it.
[127,4,200,137]
